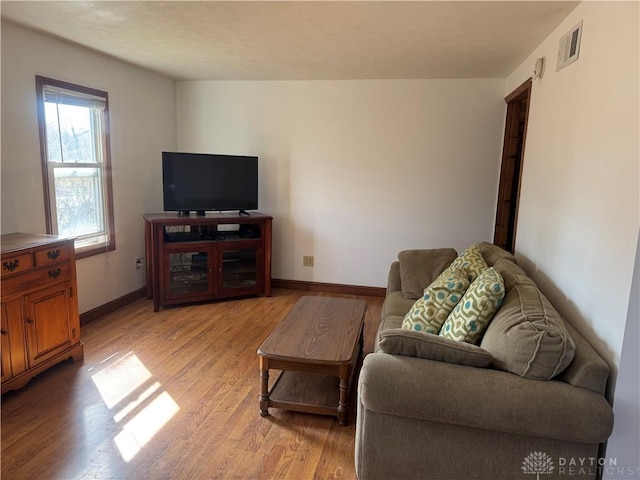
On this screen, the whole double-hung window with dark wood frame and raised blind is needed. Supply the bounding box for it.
[36,76,115,258]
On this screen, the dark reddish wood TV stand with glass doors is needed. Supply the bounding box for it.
[144,212,273,312]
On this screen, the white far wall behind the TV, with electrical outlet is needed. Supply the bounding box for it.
[177,79,505,287]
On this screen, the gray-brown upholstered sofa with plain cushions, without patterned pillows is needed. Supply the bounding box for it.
[355,243,613,480]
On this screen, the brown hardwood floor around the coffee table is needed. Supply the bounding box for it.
[1,289,383,480]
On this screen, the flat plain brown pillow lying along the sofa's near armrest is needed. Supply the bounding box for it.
[378,328,492,367]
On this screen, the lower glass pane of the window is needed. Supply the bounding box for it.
[53,167,104,236]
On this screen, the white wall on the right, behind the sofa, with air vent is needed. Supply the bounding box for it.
[506,2,640,370]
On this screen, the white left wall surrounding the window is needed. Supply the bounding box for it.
[0,22,176,313]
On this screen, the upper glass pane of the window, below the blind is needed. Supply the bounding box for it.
[44,102,98,163]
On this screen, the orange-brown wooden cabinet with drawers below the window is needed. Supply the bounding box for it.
[0,233,84,393]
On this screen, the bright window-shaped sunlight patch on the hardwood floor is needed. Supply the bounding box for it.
[91,352,180,462]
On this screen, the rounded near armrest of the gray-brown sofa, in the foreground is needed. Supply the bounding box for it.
[358,352,613,443]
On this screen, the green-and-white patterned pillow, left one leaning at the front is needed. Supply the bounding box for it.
[402,270,469,335]
